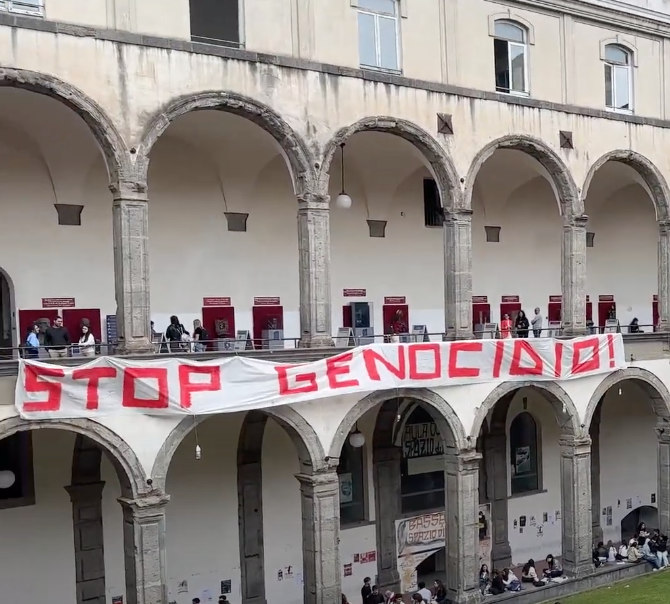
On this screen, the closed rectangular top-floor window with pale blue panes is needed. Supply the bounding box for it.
[357,0,400,71]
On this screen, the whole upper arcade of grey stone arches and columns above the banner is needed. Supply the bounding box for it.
[0,69,670,352]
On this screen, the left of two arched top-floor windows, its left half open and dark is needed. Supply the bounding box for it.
[493,21,528,94]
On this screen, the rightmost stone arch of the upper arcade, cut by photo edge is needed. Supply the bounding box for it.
[581,149,670,220]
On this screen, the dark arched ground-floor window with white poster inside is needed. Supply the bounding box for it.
[509,411,540,495]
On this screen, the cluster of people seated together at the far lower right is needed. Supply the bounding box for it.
[593,522,670,570]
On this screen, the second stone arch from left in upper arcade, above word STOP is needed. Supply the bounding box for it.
[137,91,314,195]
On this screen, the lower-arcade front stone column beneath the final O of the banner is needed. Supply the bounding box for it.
[559,436,594,578]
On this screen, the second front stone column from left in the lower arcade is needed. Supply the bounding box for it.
[296,471,342,604]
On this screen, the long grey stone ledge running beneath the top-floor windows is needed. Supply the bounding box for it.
[0,13,670,128]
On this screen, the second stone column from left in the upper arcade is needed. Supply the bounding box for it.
[298,192,333,348]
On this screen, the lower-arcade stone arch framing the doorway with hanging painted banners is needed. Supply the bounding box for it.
[329,388,472,459]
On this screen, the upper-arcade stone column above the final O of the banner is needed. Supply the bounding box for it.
[561,215,588,336]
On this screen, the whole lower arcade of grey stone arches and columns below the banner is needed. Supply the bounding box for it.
[0,368,670,604]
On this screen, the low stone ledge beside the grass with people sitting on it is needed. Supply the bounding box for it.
[490,563,652,604]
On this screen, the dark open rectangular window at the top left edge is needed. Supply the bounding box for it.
[189,0,241,48]
